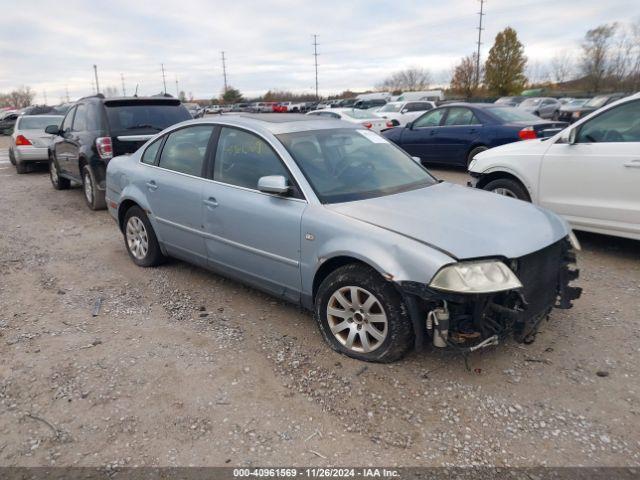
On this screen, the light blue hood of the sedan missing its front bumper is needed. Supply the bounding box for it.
[327,182,569,260]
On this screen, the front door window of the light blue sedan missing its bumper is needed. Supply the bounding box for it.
[213,127,289,190]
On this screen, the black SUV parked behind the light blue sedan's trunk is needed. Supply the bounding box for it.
[46,94,191,210]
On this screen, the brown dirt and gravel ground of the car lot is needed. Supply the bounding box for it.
[0,137,640,466]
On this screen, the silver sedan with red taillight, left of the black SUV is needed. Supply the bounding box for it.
[9,115,62,173]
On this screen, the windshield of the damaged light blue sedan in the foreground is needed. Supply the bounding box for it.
[278,128,436,203]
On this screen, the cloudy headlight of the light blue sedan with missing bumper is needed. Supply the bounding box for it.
[429,260,522,293]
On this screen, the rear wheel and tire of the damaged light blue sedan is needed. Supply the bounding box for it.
[122,205,165,267]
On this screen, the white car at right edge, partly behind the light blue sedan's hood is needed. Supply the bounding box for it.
[469,93,640,240]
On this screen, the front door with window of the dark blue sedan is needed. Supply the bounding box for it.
[400,108,446,163]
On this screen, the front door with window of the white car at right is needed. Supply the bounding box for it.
[539,100,640,235]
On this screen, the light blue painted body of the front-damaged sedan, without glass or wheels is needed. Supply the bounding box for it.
[107,116,569,306]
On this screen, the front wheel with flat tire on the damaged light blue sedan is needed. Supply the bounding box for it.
[314,263,414,363]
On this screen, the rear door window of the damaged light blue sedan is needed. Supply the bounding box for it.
[157,125,213,177]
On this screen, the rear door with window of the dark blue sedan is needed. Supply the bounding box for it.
[438,107,482,166]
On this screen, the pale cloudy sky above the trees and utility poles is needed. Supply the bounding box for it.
[0,0,640,104]
